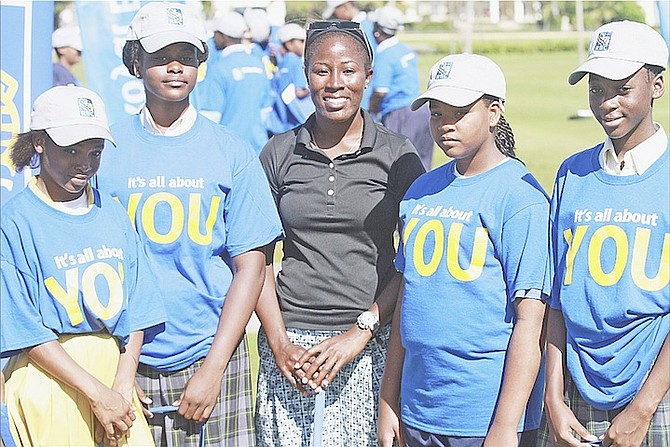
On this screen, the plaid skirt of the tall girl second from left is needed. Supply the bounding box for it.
[137,335,256,447]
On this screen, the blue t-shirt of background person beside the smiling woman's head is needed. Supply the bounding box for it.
[268,53,314,134]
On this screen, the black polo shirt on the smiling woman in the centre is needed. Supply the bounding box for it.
[260,111,424,330]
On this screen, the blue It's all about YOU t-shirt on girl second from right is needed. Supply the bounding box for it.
[396,159,549,436]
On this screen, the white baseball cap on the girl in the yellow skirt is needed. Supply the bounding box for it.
[30,84,116,146]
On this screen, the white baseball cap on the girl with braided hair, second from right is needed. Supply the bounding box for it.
[411,53,505,110]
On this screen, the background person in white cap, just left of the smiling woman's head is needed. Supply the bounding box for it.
[268,23,314,134]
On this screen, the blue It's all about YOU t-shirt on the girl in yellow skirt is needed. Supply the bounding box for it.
[0,183,165,357]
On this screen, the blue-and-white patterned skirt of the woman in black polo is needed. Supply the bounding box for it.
[255,325,390,447]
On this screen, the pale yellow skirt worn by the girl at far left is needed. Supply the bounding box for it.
[4,334,154,447]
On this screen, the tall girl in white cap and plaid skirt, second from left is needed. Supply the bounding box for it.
[97,2,282,447]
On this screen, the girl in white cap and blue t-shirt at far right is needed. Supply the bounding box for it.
[539,21,670,447]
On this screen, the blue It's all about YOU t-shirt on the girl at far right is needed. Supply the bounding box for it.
[551,144,670,410]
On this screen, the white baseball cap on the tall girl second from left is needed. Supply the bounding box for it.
[126,2,207,53]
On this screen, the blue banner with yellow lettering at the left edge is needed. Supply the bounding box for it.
[0,0,54,204]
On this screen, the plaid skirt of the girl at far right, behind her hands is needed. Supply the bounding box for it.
[537,374,670,447]
